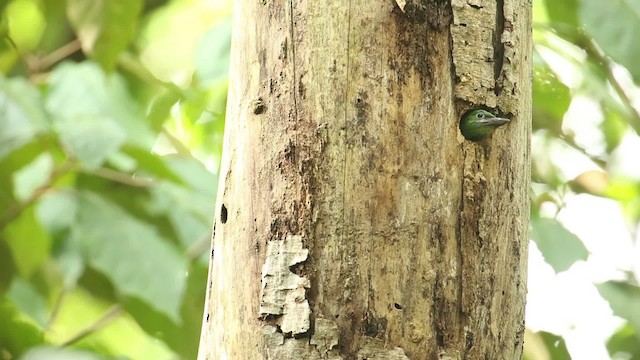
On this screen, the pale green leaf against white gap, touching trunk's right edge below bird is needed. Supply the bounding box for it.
[531,218,589,273]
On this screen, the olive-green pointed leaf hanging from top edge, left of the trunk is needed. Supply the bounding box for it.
[67,0,143,71]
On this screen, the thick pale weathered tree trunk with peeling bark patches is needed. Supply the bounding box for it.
[199,0,531,360]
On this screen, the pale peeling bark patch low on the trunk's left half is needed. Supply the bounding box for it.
[260,236,311,335]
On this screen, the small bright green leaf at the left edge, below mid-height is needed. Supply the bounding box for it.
[2,206,51,278]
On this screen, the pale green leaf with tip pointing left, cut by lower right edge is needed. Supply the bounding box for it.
[596,281,640,330]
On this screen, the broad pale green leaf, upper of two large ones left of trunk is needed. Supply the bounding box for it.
[46,61,156,149]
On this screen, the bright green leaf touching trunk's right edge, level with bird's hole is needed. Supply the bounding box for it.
[533,63,571,133]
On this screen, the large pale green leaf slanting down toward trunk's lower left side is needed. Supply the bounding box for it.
[73,193,187,322]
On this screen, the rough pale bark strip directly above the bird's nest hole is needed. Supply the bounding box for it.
[451,0,501,107]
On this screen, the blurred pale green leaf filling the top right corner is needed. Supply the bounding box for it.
[579,0,640,82]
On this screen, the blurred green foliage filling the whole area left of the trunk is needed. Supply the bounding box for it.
[0,0,230,359]
